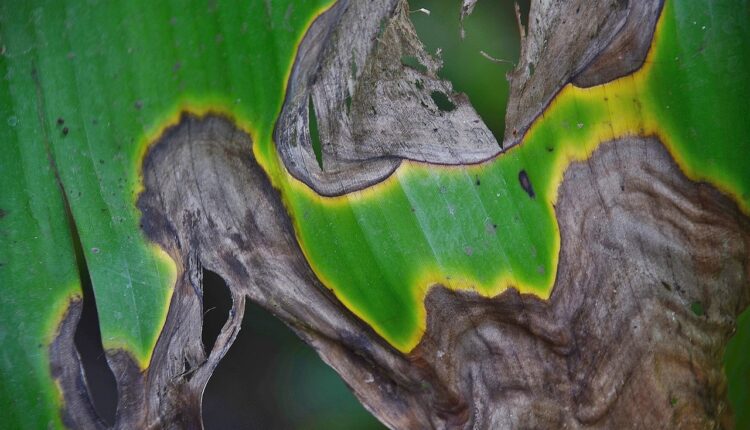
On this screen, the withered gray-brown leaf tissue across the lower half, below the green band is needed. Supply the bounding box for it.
[52,115,750,429]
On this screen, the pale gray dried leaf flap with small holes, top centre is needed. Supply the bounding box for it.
[275,0,500,195]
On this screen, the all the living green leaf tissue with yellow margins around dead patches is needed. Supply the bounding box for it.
[0,0,750,428]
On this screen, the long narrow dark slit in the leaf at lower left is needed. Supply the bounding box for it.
[73,245,117,425]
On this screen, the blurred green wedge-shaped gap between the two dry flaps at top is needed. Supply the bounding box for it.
[409,0,529,145]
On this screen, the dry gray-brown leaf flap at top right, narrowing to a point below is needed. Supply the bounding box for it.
[504,0,663,143]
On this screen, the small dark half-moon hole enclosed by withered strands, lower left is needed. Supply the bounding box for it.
[201,269,234,354]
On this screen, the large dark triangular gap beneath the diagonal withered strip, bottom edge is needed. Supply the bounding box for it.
[203,298,383,430]
